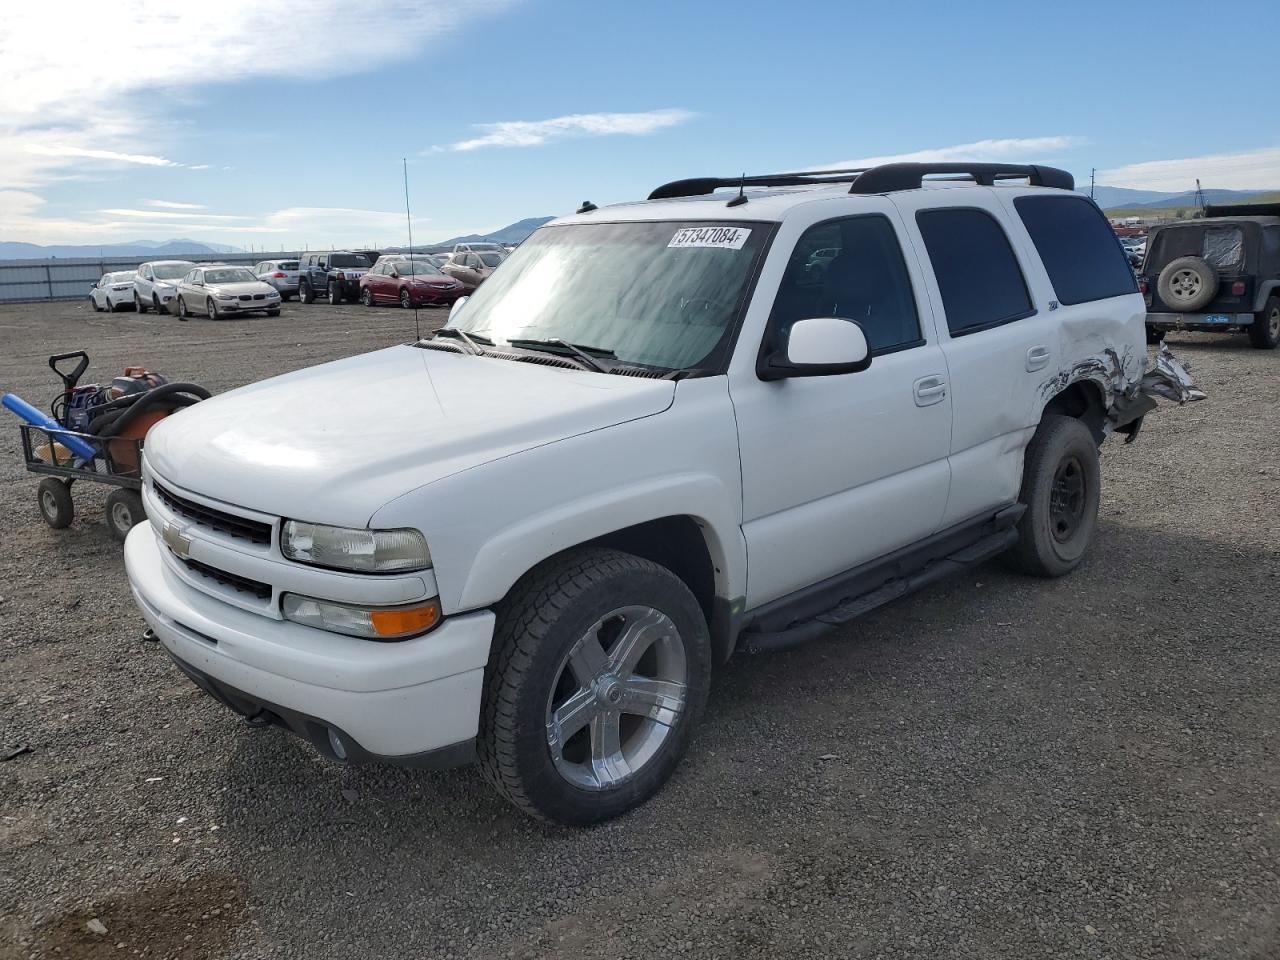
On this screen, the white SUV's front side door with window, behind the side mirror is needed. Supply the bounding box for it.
[730,198,951,608]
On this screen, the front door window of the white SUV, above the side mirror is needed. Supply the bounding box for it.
[769,216,922,353]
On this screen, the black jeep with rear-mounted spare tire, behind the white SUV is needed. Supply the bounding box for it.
[1139,204,1280,349]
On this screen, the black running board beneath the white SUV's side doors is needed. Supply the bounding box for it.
[739,508,1023,653]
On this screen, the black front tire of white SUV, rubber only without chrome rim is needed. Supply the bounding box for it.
[477,548,712,826]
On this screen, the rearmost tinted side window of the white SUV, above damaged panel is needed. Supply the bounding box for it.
[1014,197,1138,303]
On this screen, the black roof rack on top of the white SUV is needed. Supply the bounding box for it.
[649,163,1075,200]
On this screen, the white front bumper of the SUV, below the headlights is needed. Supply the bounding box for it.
[124,522,494,767]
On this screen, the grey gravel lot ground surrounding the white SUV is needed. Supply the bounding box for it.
[0,303,1280,960]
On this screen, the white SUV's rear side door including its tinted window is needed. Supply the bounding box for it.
[893,187,1061,527]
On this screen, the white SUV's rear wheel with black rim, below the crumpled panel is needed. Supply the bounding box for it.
[1005,413,1100,577]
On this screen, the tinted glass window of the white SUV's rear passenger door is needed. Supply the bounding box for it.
[915,207,1036,337]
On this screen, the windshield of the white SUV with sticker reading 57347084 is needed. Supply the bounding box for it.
[449,223,769,370]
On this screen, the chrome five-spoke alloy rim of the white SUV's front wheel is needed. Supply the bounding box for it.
[547,607,689,790]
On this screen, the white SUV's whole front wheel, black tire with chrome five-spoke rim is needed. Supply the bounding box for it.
[477,548,712,826]
